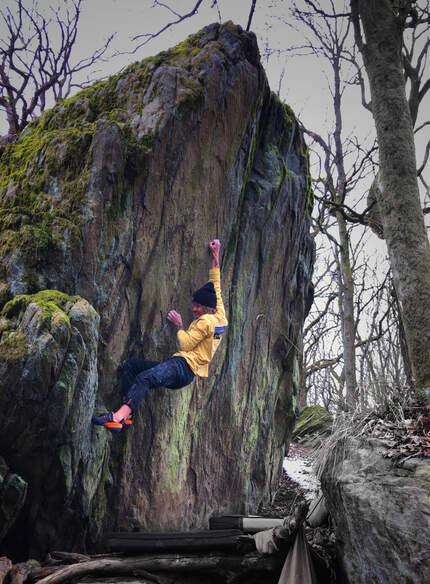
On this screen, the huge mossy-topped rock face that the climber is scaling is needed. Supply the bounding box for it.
[0,23,312,549]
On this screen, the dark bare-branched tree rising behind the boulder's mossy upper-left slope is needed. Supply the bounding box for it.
[0,0,113,142]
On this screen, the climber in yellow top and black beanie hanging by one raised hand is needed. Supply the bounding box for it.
[92,239,228,432]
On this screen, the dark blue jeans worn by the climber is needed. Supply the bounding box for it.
[122,357,194,412]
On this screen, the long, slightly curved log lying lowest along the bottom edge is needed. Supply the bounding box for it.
[34,553,282,584]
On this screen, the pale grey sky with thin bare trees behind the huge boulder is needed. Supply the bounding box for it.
[0,0,430,412]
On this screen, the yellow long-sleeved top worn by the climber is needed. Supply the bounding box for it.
[174,268,228,377]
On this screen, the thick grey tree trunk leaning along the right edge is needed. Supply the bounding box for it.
[351,0,430,388]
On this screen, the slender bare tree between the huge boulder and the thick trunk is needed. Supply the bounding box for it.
[291,0,376,408]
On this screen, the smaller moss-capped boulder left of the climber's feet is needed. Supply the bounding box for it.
[0,290,101,553]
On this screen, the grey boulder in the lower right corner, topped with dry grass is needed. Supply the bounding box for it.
[321,425,430,584]
